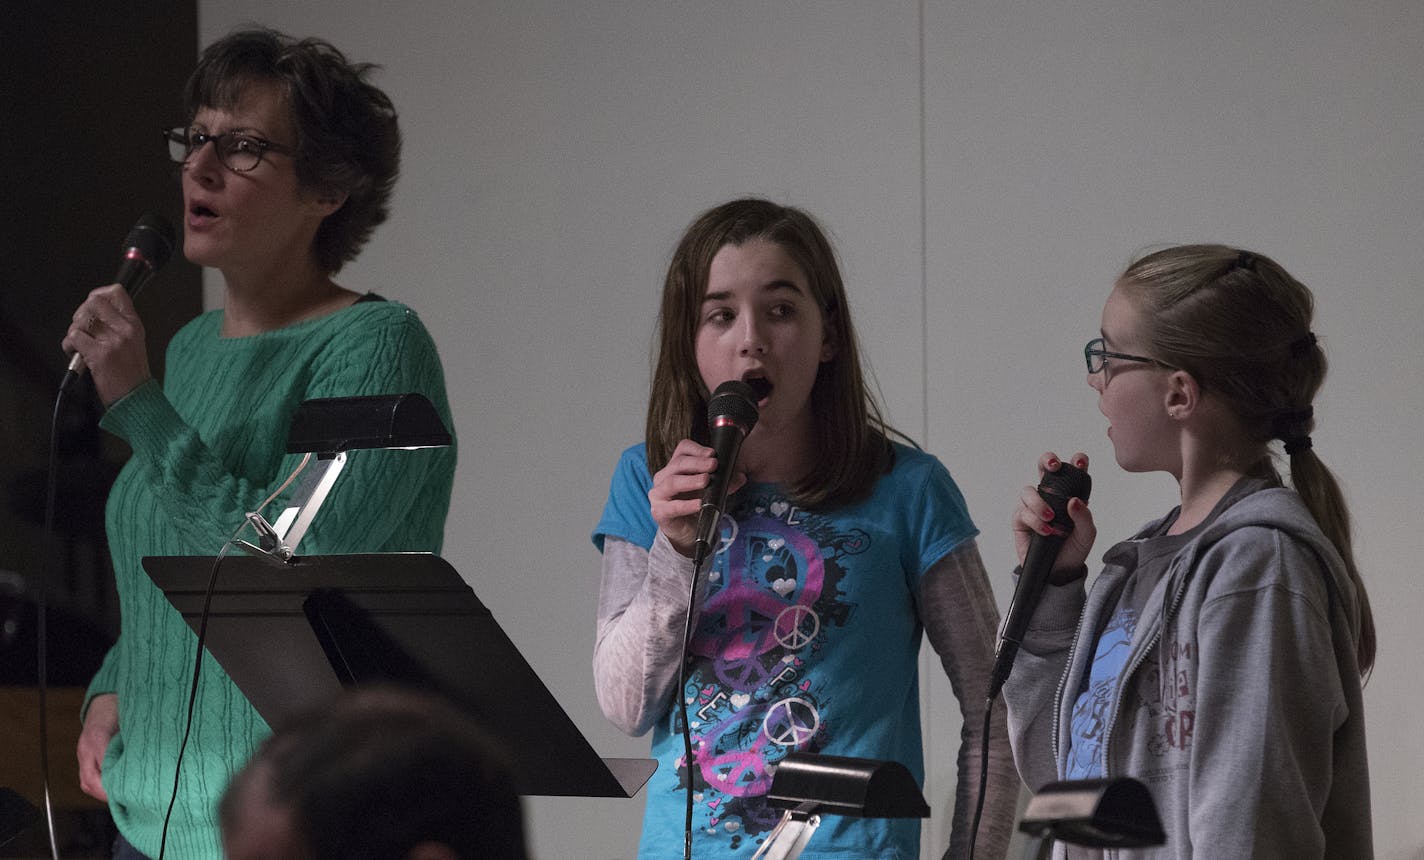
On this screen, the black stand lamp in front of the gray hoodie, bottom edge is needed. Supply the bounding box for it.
[1018,776,1166,860]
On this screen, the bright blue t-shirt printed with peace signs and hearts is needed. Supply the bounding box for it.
[594,444,978,860]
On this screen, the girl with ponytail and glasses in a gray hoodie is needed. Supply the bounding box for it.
[1004,245,1376,860]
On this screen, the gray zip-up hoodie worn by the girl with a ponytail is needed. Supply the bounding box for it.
[1004,487,1373,860]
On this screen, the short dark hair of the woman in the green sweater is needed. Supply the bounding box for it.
[184,28,400,273]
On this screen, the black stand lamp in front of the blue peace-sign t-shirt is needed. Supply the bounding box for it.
[752,753,930,860]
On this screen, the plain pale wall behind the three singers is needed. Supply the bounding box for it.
[199,0,1424,860]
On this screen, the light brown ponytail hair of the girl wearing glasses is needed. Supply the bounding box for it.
[1119,245,1376,673]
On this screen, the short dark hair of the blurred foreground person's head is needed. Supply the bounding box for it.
[219,688,528,860]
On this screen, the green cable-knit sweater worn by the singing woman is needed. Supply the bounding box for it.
[85,300,456,860]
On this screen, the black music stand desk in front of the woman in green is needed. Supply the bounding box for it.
[142,552,658,797]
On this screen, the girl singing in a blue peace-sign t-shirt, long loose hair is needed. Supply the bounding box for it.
[594,199,1018,860]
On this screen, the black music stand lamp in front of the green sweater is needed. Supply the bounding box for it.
[238,394,451,561]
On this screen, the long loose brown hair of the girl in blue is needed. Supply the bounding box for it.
[646,198,893,508]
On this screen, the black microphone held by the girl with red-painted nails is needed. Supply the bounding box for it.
[988,463,1092,701]
